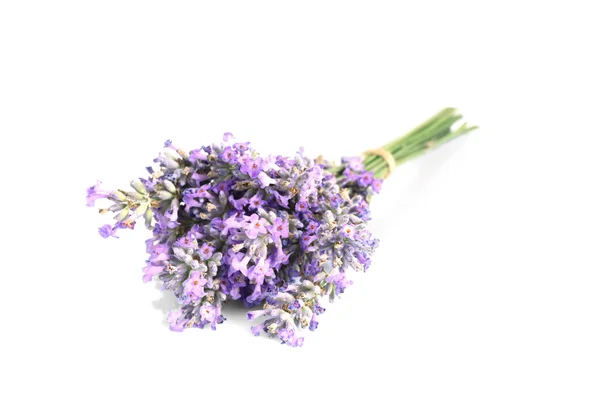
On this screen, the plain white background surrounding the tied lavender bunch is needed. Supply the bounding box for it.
[0,1,600,399]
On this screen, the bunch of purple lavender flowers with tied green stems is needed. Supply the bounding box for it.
[87,108,475,346]
